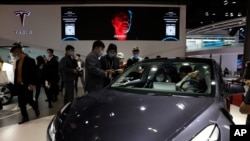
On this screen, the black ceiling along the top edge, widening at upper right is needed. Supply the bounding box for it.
[0,0,248,29]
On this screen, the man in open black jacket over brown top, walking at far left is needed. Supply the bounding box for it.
[10,43,40,124]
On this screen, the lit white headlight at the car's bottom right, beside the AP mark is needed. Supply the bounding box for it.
[191,124,220,141]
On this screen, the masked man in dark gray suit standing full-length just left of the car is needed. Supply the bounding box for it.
[59,45,77,104]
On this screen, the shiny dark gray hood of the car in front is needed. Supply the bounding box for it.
[60,89,214,141]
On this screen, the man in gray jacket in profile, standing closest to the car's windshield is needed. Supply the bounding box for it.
[85,40,114,93]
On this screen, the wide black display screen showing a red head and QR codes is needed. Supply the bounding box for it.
[61,6,180,41]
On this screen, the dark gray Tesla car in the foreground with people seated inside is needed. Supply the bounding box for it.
[47,57,244,141]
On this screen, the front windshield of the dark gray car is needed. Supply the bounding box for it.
[110,58,215,96]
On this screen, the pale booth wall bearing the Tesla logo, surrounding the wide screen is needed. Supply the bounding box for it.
[0,4,186,58]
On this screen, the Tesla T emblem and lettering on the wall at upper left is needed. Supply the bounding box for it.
[14,10,32,35]
